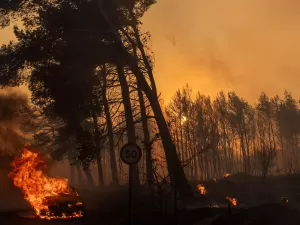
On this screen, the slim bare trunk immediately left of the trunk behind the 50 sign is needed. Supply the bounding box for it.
[102,68,119,185]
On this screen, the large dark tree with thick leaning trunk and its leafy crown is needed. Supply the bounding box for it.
[0,0,191,196]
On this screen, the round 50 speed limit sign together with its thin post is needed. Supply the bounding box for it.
[120,143,142,225]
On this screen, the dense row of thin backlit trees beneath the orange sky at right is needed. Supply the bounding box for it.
[166,85,300,180]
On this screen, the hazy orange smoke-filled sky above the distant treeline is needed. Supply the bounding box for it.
[0,0,300,102]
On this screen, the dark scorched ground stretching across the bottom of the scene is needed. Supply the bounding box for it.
[0,174,300,225]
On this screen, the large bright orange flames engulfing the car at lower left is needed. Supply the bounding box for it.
[9,149,83,219]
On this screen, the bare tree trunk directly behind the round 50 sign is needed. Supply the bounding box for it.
[117,64,140,186]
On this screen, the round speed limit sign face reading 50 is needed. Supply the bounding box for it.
[120,143,142,165]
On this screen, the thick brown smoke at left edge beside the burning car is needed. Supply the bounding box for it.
[0,88,32,212]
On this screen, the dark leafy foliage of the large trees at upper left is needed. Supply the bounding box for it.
[0,0,155,167]
